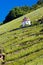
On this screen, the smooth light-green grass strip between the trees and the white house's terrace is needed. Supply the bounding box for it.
[0,7,43,34]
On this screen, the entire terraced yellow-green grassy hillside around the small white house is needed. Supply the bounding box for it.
[0,7,43,65]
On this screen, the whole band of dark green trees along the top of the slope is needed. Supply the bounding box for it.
[3,0,43,24]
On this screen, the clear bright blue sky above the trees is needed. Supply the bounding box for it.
[0,0,37,22]
